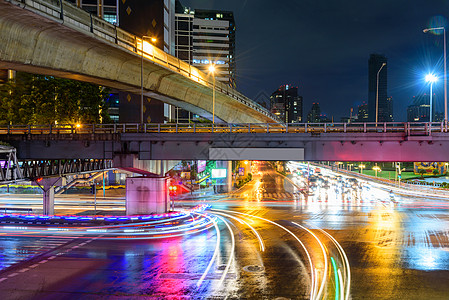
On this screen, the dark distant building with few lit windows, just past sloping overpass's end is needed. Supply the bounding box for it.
[270,84,303,123]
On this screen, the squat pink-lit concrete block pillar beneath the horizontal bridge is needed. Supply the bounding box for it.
[126,176,170,215]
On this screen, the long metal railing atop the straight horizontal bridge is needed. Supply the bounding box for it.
[0,122,448,136]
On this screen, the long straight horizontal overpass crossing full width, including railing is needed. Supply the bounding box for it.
[0,123,449,162]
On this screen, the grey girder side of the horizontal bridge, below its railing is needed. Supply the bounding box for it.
[6,133,449,162]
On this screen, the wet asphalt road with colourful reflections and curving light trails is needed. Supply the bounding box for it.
[0,165,449,299]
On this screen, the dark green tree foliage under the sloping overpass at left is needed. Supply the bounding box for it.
[0,73,110,124]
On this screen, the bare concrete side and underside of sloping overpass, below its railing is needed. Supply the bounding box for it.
[0,0,275,123]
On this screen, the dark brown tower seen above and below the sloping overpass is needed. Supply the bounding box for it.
[65,0,175,123]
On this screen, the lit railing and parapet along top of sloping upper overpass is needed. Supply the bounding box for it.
[6,0,278,121]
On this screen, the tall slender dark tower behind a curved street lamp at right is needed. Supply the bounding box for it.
[368,54,393,122]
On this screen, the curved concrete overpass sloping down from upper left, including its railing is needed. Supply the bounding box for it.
[0,0,278,123]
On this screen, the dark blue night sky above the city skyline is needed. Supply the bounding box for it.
[181,0,449,122]
